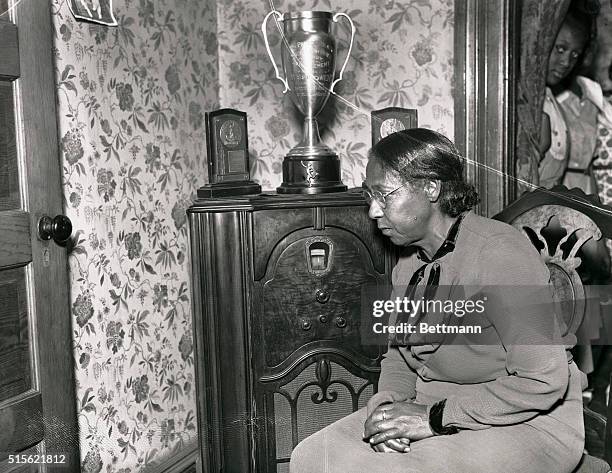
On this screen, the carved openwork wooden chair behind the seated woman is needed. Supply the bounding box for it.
[493,186,612,472]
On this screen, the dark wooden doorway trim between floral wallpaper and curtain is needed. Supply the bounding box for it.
[454,0,519,216]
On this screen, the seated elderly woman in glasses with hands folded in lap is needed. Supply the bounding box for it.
[290,128,584,473]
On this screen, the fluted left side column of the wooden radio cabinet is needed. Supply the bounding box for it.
[190,211,257,473]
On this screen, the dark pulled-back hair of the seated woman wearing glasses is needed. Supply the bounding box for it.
[368,128,479,217]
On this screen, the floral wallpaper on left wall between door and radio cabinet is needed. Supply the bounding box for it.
[51,0,218,473]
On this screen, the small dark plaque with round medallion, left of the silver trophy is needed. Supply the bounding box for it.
[198,108,261,198]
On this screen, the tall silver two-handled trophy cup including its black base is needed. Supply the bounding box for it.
[261,10,355,194]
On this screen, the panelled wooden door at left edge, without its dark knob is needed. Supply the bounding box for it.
[0,0,79,472]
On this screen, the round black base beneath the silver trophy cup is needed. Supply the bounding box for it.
[276,154,347,194]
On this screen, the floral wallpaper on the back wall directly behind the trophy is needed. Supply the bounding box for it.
[217,0,454,189]
